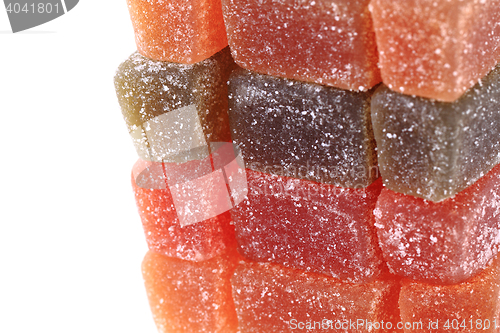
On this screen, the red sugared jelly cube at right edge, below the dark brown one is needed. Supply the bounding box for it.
[374,165,500,284]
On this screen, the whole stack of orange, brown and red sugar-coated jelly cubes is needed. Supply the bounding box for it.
[115,0,500,333]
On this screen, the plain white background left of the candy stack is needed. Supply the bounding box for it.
[0,0,158,333]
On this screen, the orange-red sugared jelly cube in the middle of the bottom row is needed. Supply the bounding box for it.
[232,262,401,333]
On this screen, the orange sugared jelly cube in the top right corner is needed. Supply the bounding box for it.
[370,0,500,102]
